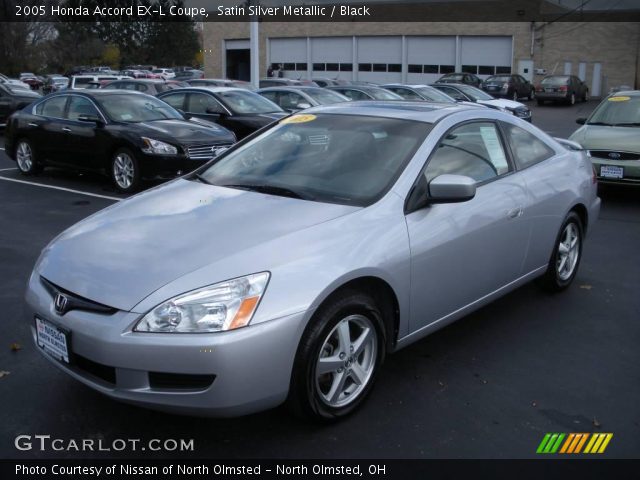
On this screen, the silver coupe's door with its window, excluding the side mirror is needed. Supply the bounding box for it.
[406,121,529,331]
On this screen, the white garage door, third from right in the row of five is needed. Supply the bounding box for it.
[356,36,402,83]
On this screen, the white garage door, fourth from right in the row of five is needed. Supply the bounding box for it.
[310,37,353,80]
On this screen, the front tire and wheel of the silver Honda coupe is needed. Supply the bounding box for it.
[288,291,385,422]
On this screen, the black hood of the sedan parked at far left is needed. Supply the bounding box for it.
[133,119,235,145]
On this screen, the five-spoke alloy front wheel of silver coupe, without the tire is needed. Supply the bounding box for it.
[315,315,378,408]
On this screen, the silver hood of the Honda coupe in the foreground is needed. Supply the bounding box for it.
[36,179,359,311]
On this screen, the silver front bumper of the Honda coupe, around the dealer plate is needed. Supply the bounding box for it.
[25,274,307,416]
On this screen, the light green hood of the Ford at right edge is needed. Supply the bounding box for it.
[569,125,640,152]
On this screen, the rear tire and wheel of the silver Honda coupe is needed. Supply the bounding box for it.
[540,212,584,292]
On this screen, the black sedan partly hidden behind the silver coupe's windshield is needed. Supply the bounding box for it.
[158,87,286,140]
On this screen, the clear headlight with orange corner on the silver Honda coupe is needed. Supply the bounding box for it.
[134,272,269,333]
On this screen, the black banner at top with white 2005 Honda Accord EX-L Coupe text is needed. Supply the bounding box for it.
[0,0,640,22]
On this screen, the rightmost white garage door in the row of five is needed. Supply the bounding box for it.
[460,36,513,78]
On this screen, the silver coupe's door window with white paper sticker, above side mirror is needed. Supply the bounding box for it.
[425,122,511,182]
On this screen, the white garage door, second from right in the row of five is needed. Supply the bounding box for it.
[407,36,456,84]
